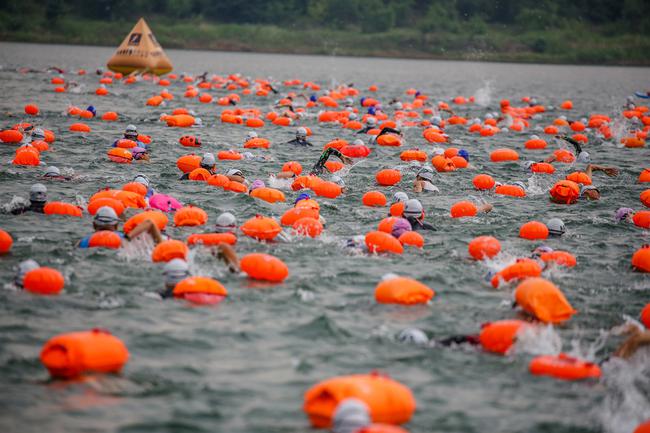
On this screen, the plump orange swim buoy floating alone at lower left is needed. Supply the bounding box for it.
[40,329,129,379]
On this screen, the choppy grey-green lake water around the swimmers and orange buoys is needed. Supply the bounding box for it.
[0,43,650,433]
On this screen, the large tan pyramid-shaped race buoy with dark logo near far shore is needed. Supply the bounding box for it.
[106,18,174,75]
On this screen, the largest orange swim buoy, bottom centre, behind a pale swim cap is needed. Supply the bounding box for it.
[303,374,415,428]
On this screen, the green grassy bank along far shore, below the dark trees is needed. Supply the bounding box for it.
[0,14,650,65]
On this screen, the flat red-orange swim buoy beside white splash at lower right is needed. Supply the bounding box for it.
[528,353,602,380]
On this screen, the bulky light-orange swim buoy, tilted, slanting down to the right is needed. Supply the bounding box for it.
[515,277,577,323]
